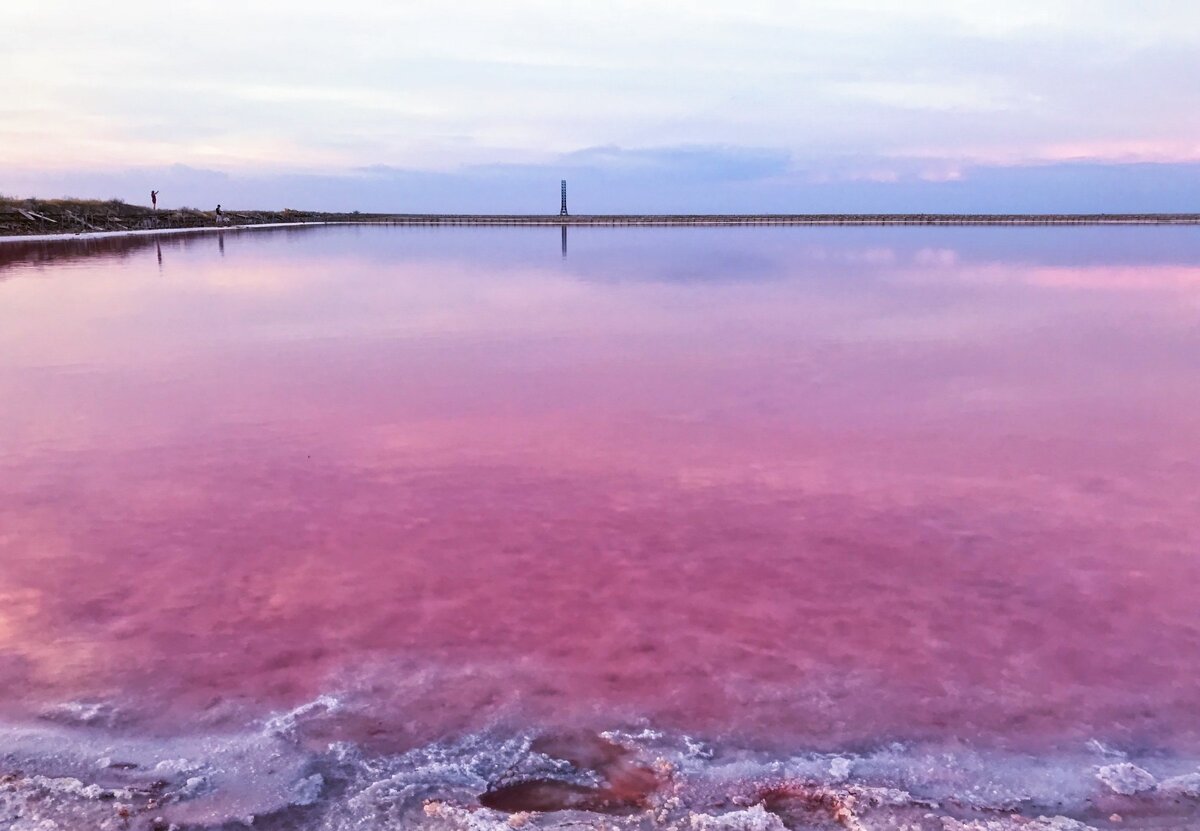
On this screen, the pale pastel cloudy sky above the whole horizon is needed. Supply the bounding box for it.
[0,0,1200,213]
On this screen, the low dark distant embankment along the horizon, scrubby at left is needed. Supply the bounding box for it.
[0,198,1200,237]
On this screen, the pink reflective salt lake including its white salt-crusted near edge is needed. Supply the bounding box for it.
[0,227,1200,831]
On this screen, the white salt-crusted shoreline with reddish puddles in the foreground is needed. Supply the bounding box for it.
[0,694,1200,831]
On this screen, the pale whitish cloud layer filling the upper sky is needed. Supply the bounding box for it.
[0,0,1200,175]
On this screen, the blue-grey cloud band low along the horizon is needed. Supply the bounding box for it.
[7,145,1200,214]
